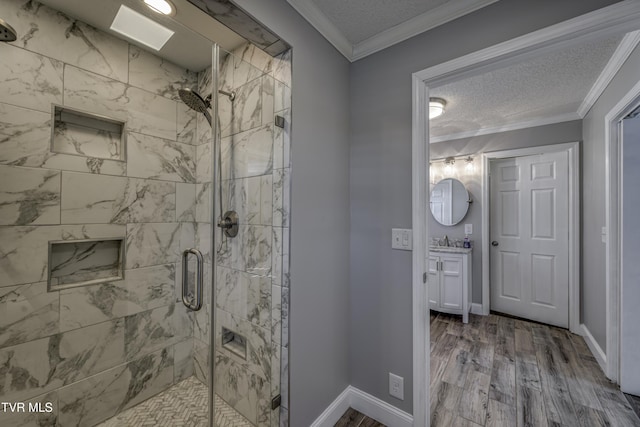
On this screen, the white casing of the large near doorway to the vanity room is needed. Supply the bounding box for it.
[411,0,640,427]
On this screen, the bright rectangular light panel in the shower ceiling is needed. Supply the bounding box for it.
[111,5,174,50]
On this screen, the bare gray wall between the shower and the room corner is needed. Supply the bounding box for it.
[237,0,349,426]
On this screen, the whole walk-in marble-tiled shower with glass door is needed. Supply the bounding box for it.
[0,0,291,427]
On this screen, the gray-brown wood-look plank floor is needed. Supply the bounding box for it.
[336,312,640,427]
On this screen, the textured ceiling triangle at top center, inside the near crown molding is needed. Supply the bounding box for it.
[313,0,457,44]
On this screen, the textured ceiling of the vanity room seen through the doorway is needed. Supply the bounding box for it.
[429,36,622,138]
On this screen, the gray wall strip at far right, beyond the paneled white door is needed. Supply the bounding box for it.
[581,43,640,352]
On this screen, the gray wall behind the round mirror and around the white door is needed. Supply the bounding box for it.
[429,120,582,304]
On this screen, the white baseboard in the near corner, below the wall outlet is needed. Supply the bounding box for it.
[311,386,413,427]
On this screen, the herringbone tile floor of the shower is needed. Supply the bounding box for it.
[99,377,252,427]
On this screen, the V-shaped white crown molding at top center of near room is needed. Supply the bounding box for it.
[287,0,498,62]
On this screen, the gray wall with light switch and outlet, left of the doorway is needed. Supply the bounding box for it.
[348,0,615,412]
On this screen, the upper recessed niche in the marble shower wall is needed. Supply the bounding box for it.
[51,104,127,162]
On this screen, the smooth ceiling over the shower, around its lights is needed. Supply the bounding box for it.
[38,0,244,71]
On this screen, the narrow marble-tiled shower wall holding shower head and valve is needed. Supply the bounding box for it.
[209,44,291,426]
